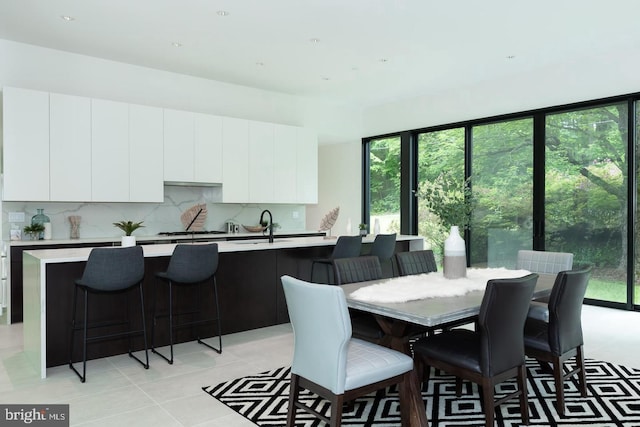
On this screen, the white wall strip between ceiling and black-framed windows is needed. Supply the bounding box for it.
[362,48,640,136]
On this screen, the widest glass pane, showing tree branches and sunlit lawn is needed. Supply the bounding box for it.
[544,103,629,304]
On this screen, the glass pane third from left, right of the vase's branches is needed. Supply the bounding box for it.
[469,118,533,268]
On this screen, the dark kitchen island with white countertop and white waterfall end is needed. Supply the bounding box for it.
[23,236,423,378]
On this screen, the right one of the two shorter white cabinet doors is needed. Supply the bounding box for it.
[193,113,222,184]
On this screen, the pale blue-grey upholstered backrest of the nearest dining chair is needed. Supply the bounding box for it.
[281,276,351,394]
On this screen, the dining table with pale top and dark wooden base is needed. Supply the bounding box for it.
[341,269,556,427]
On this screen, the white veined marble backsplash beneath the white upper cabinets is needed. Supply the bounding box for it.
[2,186,308,240]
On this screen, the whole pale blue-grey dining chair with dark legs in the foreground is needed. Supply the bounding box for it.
[281,276,413,427]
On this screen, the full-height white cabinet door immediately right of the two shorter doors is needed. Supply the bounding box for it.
[222,117,249,203]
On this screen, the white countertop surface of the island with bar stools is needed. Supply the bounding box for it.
[24,235,424,264]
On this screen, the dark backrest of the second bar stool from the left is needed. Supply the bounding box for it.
[165,243,218,283]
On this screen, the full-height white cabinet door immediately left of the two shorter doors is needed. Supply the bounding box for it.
[129,105,164,203]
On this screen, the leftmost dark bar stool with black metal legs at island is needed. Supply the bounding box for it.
[69,246,149,382]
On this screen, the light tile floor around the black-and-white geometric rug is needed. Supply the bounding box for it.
[0,306,640,427]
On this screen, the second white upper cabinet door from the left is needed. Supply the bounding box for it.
[49,93,91,202]
